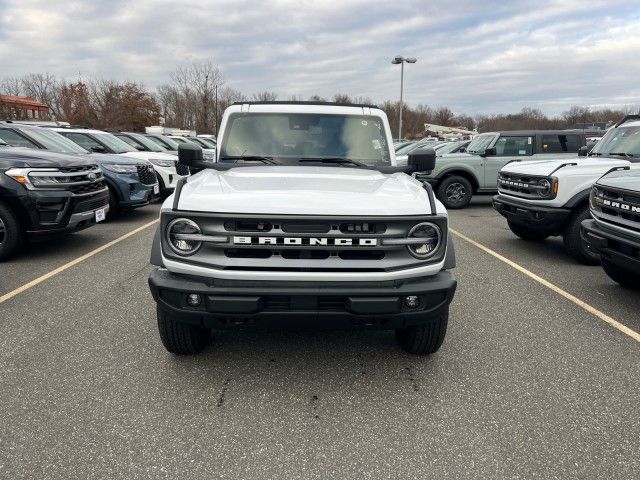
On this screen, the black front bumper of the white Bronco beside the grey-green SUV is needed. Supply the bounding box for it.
[493,195,571,234]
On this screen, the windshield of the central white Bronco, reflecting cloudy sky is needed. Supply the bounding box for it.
[220,113,391,166]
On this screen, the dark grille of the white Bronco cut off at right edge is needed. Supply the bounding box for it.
[591,185,640,231]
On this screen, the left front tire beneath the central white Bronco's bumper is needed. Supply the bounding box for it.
[157,307,211,355]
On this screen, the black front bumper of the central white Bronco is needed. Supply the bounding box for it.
[149,268,457,329]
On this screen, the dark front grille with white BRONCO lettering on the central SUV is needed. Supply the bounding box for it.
[162,212,447,272]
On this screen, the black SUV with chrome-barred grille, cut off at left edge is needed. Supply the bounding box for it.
[0,140,109,261]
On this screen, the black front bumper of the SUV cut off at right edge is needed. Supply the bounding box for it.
[580,219,640,275]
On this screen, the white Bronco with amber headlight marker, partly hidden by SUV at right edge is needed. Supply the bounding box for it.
[493,115,640,265]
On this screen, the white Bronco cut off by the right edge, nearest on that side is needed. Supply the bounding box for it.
[582,165,640,289]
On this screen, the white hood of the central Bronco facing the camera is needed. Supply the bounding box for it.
[178,166,430,216]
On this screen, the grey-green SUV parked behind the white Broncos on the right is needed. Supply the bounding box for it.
[419,130,586,208]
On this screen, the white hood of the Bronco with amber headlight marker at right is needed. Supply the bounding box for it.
[500,157,630,177]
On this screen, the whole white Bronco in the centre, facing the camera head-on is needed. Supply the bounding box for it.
[149,102,456,354]
